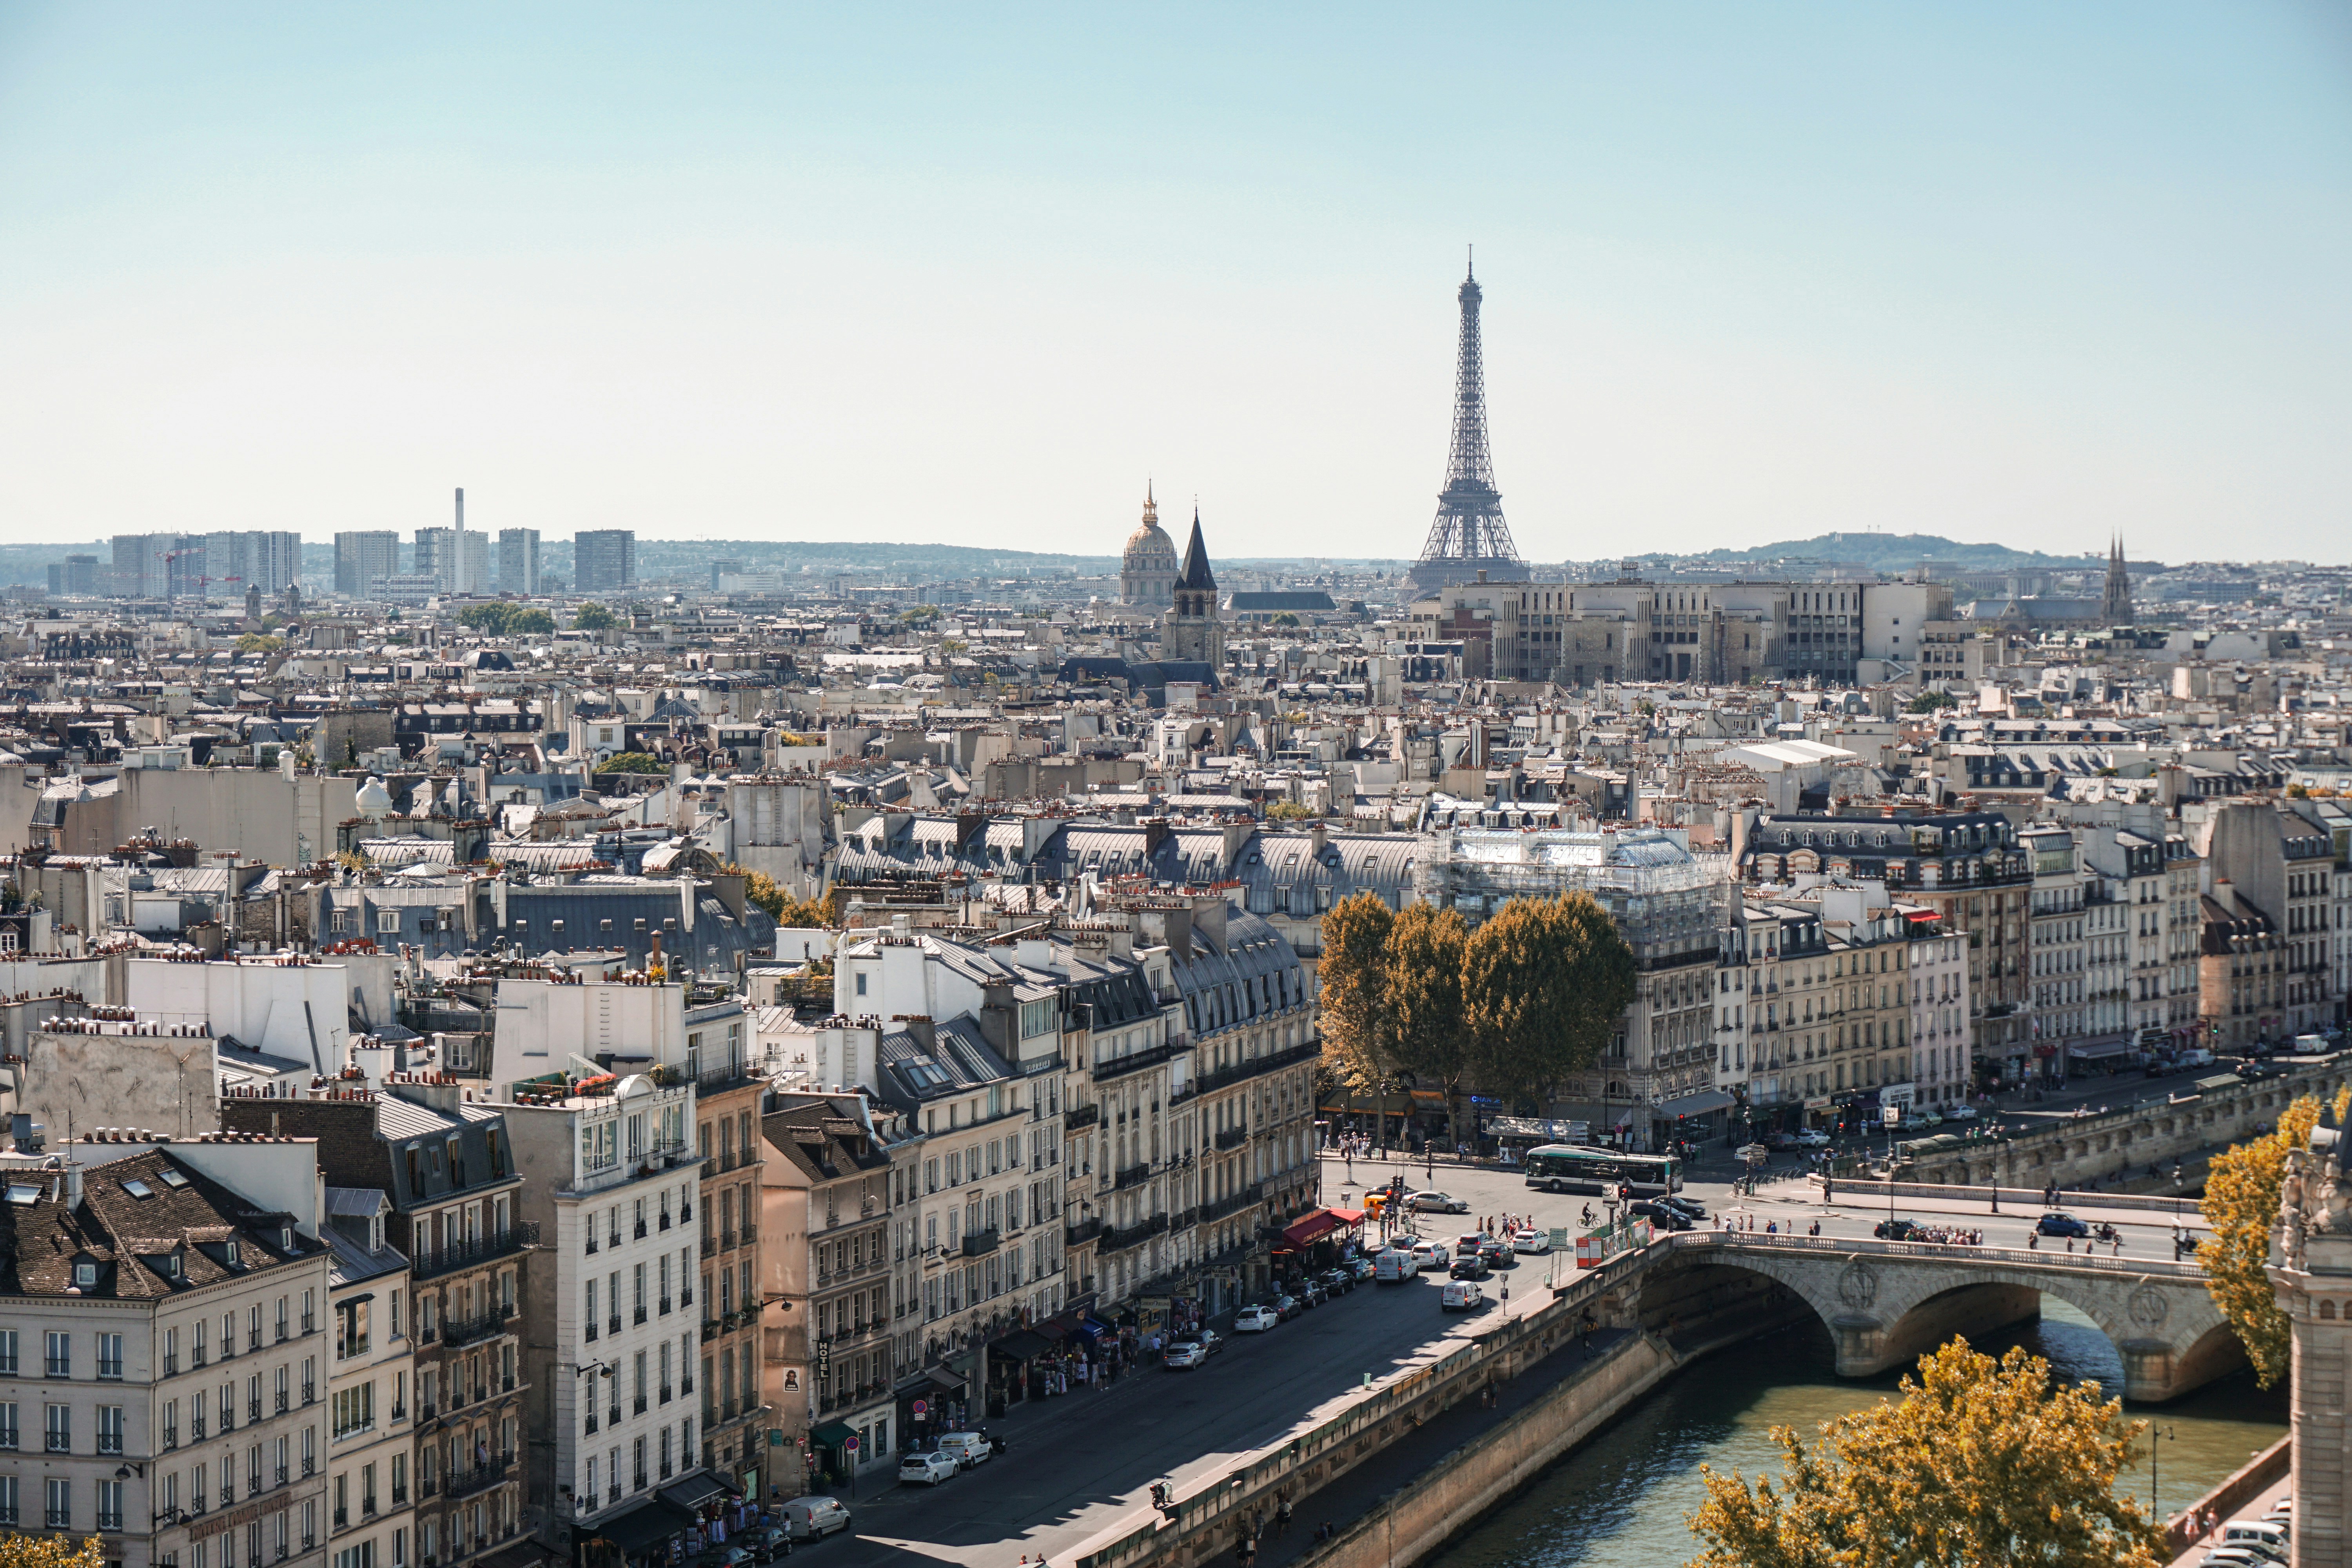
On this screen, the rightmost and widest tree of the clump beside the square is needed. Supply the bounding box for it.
[1463,893,1635,1103]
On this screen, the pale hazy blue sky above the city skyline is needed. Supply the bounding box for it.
[0,0,2352,559]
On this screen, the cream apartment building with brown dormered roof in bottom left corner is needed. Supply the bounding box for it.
[0,1136,332,1568]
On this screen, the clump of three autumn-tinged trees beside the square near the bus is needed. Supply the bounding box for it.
[1319,893,1635,1143]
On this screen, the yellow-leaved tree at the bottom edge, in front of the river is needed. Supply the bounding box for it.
[1691,1340,2164,1568]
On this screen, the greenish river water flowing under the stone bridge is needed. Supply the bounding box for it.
[1435,1295,2286,1568]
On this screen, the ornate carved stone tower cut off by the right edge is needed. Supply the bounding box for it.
[2270,1100,2352,1568]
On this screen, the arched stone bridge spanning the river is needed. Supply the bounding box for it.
[1618,1232,2244,1403]
